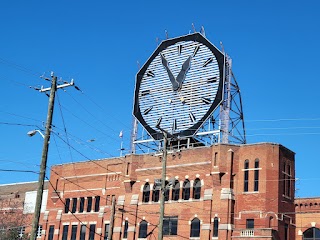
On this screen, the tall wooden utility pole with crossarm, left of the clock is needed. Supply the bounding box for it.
[30,72,74,240]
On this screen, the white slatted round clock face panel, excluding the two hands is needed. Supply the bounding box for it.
[139,41,220,137]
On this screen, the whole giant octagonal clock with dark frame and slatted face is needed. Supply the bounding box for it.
[134,33,224,140]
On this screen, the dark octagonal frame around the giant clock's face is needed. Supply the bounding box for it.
[133,33,225,140]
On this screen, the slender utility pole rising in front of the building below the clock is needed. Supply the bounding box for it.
[158,131,168,240]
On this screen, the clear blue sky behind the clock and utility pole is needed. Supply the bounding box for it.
[0,0,320,197]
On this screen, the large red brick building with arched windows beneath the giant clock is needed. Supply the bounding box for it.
[41,143,295,240]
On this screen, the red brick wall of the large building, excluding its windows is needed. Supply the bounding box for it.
[39,143,295,240]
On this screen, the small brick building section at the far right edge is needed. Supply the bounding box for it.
[295,197,320,240]
